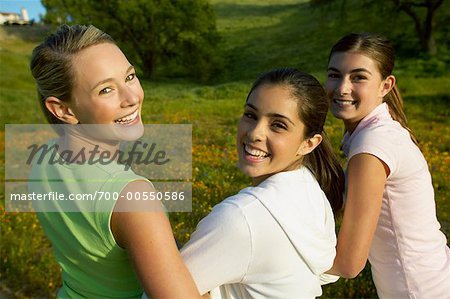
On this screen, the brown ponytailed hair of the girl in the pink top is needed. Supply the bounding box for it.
[328,33,418,145]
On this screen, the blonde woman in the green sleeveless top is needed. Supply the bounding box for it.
[31,25,199,298]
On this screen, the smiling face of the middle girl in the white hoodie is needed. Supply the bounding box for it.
[237,84,304,185]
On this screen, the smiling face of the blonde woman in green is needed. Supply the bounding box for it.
[68,43,144,140]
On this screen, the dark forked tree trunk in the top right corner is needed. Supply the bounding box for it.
[391,0,444,55]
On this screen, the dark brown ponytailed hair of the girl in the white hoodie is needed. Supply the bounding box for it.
[247,68,345,215]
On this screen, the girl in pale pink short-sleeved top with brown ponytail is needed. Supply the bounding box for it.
[325,33,450,299]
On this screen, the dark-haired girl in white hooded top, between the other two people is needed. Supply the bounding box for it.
[182,69,344,299]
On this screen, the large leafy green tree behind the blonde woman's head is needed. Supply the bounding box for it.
[42,0,222,80]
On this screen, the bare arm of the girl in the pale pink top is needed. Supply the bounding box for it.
[328,154,389,278]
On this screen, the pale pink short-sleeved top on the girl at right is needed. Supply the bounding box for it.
[342,103,450,299]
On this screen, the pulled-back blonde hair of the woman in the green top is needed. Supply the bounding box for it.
[30,25,115,124]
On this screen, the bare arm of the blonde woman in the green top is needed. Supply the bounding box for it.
[111,181,200,298]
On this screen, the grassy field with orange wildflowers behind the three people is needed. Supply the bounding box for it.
[0,0,450,298]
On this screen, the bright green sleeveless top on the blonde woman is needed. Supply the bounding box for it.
[29,144,151,298]
